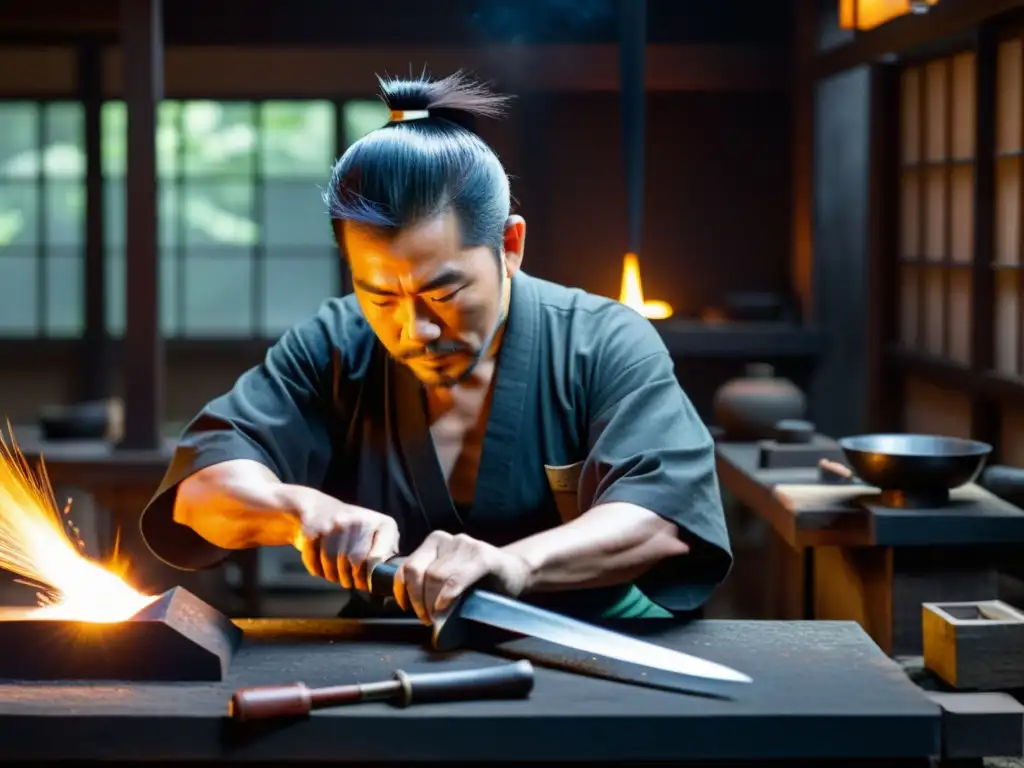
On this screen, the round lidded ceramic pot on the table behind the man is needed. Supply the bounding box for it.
[714,362,807,441]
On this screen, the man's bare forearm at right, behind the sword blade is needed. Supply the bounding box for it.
[505,502,689,592]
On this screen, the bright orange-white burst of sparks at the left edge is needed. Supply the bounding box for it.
[0,425,157,623]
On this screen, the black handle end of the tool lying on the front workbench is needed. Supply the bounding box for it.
[394,659,534,707]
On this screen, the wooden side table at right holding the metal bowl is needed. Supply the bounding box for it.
[715,442,1024,655]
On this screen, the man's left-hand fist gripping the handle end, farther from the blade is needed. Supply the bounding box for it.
[295,492,398,592]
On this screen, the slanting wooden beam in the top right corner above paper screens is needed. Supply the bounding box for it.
[813,0,1024,79]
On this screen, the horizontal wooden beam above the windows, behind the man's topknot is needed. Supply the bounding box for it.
[99,44,788,98]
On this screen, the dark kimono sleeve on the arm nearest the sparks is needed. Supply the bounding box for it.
[140,312,333,570]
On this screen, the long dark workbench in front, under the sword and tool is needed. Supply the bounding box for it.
[0,620,941,765]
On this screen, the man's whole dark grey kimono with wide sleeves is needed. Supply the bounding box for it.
[142,271,732,616]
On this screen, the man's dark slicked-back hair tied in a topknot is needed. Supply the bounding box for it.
[324,72,511,252]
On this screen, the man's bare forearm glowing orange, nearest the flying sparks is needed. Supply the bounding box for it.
[174,460,303,549]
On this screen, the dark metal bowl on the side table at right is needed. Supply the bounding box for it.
[839,434,992,506]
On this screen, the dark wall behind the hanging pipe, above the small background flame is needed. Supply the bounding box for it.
[513,92,792,313]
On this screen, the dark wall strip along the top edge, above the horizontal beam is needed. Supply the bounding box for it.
[9,0,790,46]
